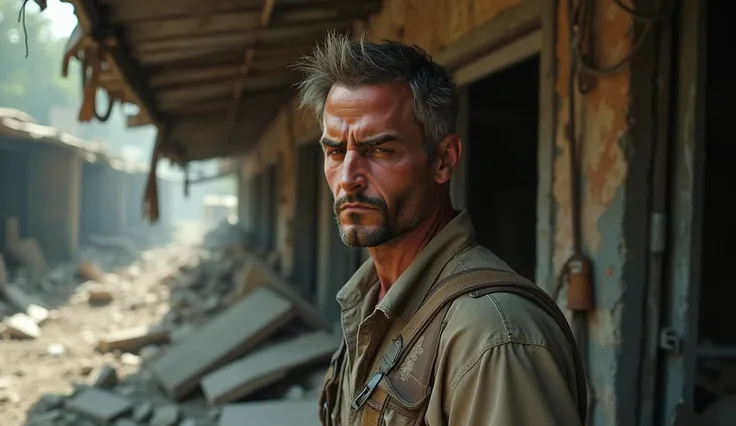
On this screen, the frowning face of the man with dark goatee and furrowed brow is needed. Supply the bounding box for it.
[321,82,434,247]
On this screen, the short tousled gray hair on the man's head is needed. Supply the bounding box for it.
[295,32,459,156]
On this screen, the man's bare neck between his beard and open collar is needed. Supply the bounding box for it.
[368,194,455,299]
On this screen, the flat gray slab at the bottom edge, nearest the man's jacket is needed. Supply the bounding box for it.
[219,401,320,426]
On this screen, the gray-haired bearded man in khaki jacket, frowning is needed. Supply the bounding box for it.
[298,34,585,426]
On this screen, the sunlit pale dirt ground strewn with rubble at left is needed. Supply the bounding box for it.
[0,227,203,426]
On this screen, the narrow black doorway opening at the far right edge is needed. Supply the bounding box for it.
[695,1,736,416]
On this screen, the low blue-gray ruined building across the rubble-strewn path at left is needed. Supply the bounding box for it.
[0,108,173,263]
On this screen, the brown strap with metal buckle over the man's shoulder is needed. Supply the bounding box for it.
[351,268,587,426]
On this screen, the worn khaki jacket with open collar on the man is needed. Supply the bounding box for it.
[330,211,580,426]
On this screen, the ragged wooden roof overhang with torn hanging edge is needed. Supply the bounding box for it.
[56,0,381,164]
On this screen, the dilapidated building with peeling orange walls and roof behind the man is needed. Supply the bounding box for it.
[17,0,736,426]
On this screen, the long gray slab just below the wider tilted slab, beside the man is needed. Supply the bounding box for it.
[201,331,338,405]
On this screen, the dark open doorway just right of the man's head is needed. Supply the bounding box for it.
[464,54,540,279]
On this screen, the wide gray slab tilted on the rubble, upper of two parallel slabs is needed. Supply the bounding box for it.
[152,288,295,399]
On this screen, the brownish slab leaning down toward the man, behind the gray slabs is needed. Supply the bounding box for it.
[234,256,332,331]
